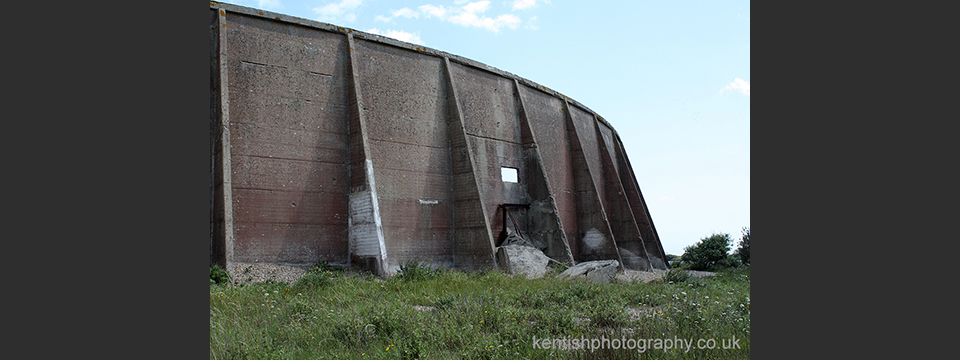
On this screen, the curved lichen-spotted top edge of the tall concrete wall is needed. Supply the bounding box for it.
[210,1,620,139]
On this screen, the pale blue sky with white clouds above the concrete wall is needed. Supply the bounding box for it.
[223,0,750,255]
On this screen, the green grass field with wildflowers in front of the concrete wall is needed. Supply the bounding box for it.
[210,266,750,359]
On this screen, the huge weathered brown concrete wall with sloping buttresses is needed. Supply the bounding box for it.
[210,2,667,275]
